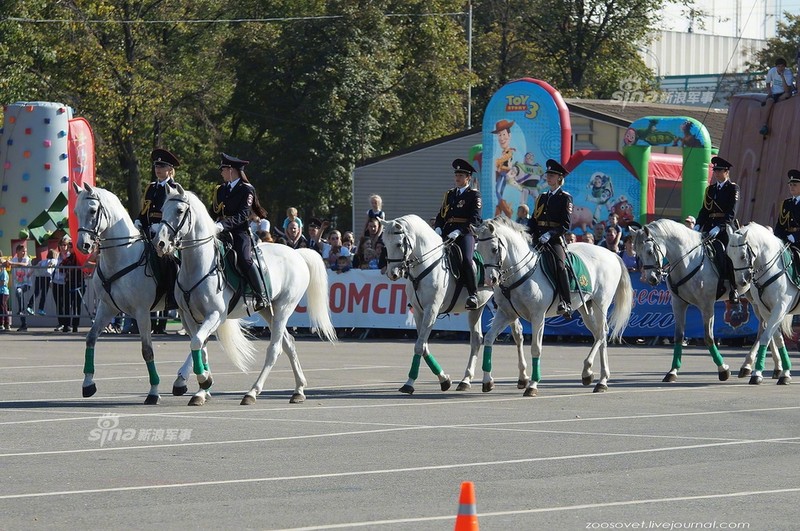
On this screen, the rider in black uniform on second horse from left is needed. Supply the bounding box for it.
[211,153,269,311]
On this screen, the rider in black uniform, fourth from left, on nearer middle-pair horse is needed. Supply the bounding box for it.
[528,159,573,318]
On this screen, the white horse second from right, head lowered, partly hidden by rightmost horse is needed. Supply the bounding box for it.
[631,219,780,382]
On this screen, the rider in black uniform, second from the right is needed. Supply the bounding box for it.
[695,157,739,303]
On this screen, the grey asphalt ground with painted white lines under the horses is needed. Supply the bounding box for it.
[0,330,800,530]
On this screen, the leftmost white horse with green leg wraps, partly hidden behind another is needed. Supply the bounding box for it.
[72,182,191,404]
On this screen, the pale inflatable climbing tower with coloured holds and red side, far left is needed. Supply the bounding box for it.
[0,102,94,258]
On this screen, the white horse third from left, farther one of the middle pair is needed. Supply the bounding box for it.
[381,214,529,394]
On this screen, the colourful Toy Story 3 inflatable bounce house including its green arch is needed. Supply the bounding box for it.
[470,78,711,239]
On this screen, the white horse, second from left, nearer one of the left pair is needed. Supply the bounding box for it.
[153,185,336,405]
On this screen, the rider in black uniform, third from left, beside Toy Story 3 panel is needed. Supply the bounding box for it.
[433,159,481,310]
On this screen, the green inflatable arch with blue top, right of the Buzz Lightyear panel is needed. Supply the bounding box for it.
[623,116,711,223]
